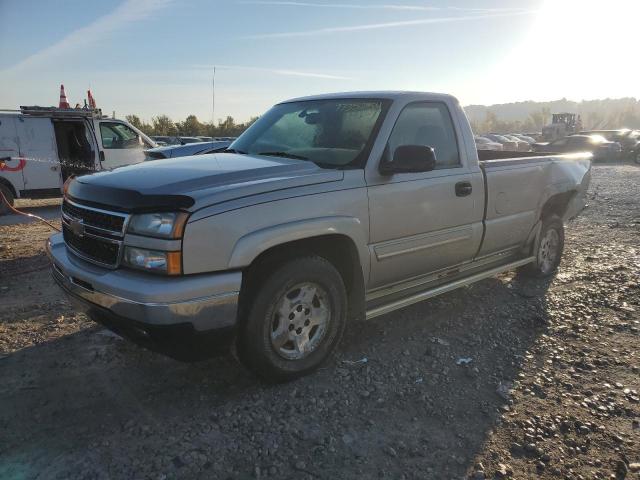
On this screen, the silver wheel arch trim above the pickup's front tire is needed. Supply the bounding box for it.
[229,216,369,282]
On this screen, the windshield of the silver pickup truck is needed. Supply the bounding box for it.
[230,99,388,167]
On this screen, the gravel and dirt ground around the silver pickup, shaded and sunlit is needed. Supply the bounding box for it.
[0,165,640,479]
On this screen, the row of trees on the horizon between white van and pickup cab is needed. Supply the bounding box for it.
[126,115,258,137]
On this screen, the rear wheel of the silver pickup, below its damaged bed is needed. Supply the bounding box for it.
[518,215,564,278]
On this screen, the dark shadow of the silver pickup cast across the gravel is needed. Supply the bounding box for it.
[0,275,549,478]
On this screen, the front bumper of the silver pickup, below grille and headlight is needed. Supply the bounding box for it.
[46,234,242,332]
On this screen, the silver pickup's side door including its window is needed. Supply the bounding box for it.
[368,102,484,289]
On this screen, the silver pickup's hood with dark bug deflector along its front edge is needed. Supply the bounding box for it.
[67,153,343,212]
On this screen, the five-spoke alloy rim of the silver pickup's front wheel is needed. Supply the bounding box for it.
[270,282,331,360]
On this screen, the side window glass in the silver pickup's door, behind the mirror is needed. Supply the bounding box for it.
[388,102,460,169]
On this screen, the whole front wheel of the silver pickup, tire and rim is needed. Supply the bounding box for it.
[237,256,347,382]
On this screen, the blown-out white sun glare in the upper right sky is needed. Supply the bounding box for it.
[474,0,640,102]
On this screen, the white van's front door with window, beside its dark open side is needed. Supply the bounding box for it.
[99,121,145,169]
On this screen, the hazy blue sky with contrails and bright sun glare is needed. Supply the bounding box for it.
[0,0,640,122]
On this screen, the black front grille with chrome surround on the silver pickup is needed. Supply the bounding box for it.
[62,199,127,268]
